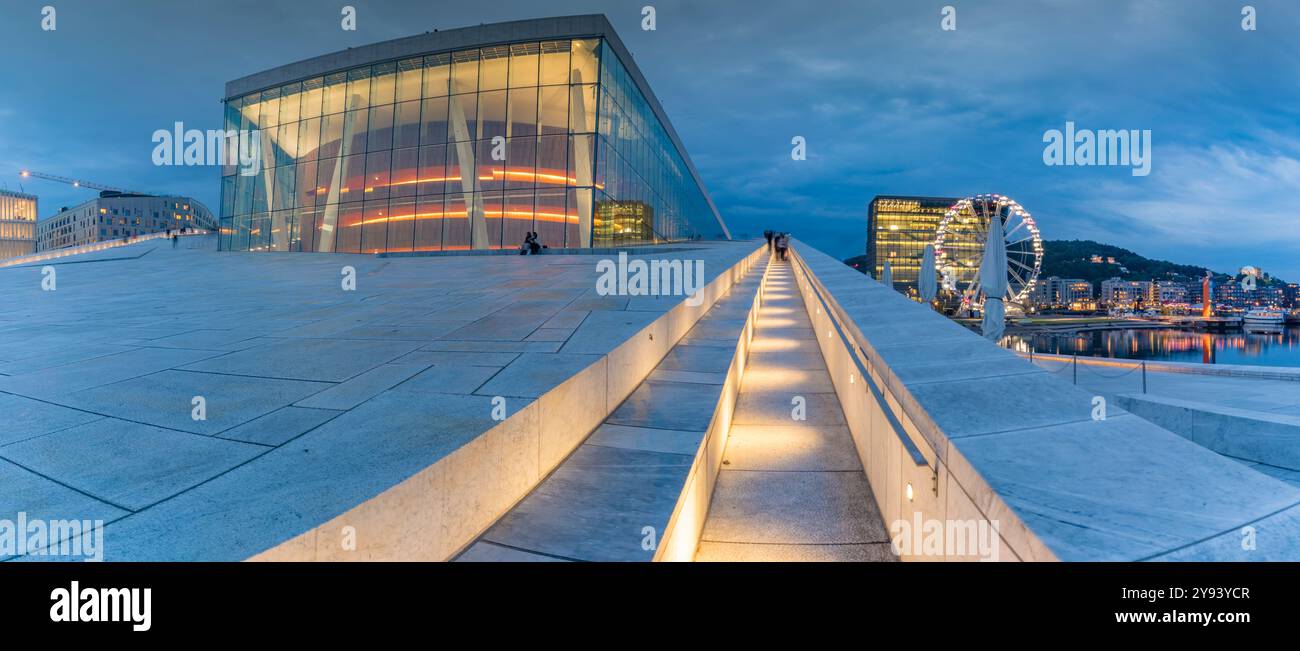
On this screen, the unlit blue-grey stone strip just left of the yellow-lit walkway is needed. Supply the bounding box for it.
[456,253,764,563]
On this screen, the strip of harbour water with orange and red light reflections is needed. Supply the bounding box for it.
[1002,326,1300,366]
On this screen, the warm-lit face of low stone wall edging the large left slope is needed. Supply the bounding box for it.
[248,242,767,561]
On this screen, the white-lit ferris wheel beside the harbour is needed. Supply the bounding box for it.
[935,195,1043,307]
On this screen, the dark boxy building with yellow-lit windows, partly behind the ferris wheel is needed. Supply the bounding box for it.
[867,195,958,295]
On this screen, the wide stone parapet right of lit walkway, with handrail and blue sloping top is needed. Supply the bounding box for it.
[793,242,1300,560]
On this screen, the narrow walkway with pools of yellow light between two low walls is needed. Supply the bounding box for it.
[696,261,894,561]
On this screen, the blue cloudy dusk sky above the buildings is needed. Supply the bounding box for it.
[0,0,1300,281]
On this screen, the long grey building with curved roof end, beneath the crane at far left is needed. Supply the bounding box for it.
[36,191,217,251]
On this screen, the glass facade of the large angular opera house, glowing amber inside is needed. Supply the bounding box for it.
[221,38,725,253]
